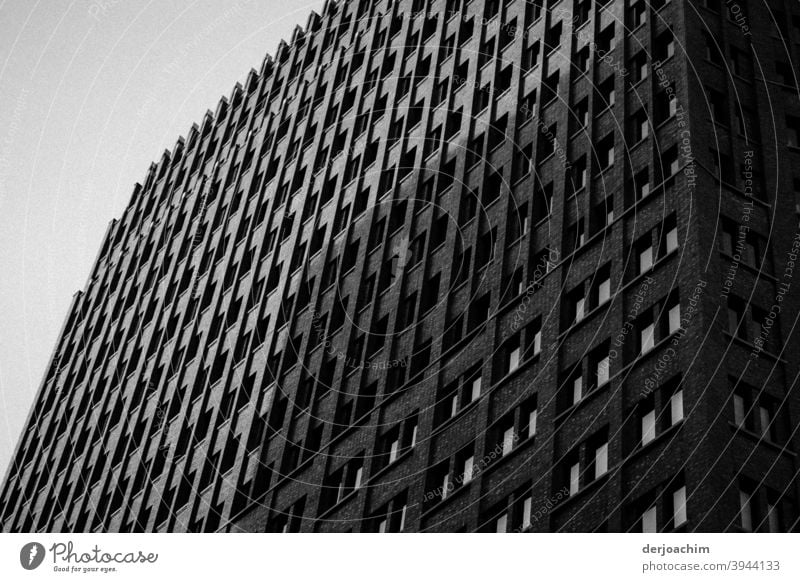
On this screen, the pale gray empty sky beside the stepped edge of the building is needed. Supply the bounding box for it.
[0,0,323,479]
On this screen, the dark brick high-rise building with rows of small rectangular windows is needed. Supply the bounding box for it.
[0,0,800,532]
